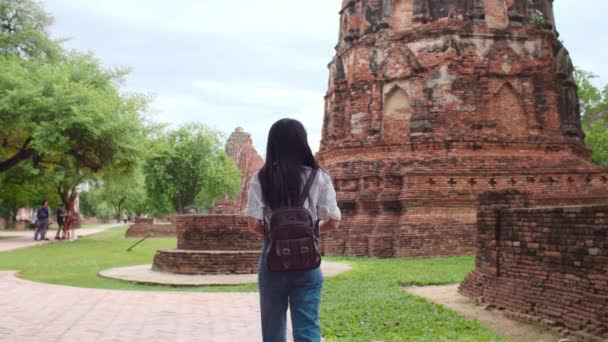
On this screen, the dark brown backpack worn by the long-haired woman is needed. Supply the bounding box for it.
[264,169,321,272]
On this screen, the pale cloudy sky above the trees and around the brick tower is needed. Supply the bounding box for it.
[42,0,608,155]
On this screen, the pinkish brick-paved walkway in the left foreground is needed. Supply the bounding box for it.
[0,272,261,342]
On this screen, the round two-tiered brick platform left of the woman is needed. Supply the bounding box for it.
[152,215,262,275]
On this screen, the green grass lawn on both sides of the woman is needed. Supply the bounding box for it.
[0,227,504,341]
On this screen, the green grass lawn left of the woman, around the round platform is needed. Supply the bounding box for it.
[0,227,256,292]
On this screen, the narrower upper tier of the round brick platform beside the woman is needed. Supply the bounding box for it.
[175,215,262,251]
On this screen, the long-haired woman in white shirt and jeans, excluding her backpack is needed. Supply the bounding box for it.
[246,119,341,342]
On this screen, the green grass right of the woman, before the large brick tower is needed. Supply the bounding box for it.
[321,257,506,341]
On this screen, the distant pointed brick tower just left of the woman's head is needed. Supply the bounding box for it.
[212,127,264,214]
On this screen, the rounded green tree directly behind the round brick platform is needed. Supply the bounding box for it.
[144,124,240,214]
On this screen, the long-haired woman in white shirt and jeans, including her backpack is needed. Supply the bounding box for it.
[246,119,341,342]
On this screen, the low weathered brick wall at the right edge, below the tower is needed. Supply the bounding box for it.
[460,192,608,341]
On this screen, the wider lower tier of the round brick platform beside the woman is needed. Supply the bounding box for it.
[152,249,260,275]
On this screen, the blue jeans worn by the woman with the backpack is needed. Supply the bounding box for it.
[258,246,323,342]
